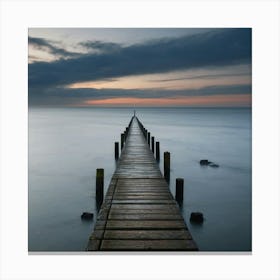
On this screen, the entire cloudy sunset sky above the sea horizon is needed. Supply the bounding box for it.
[28,28,252,107]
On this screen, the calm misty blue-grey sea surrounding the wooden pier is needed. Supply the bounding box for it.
[28,108,252,251]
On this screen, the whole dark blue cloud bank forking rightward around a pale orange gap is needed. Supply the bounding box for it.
[28,28,251,105]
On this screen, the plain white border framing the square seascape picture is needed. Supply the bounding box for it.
[0,0,280,280]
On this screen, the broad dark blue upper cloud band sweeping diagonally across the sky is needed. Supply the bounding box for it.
[29,28,251,88]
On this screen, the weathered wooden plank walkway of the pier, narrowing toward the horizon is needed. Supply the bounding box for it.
[86,116,198,251]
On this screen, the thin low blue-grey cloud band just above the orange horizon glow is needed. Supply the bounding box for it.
[29,85,251,106]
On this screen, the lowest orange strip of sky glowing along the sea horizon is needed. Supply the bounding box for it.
[81,94,251,106]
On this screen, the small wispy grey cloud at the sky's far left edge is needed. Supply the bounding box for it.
[28,37,81,58]
